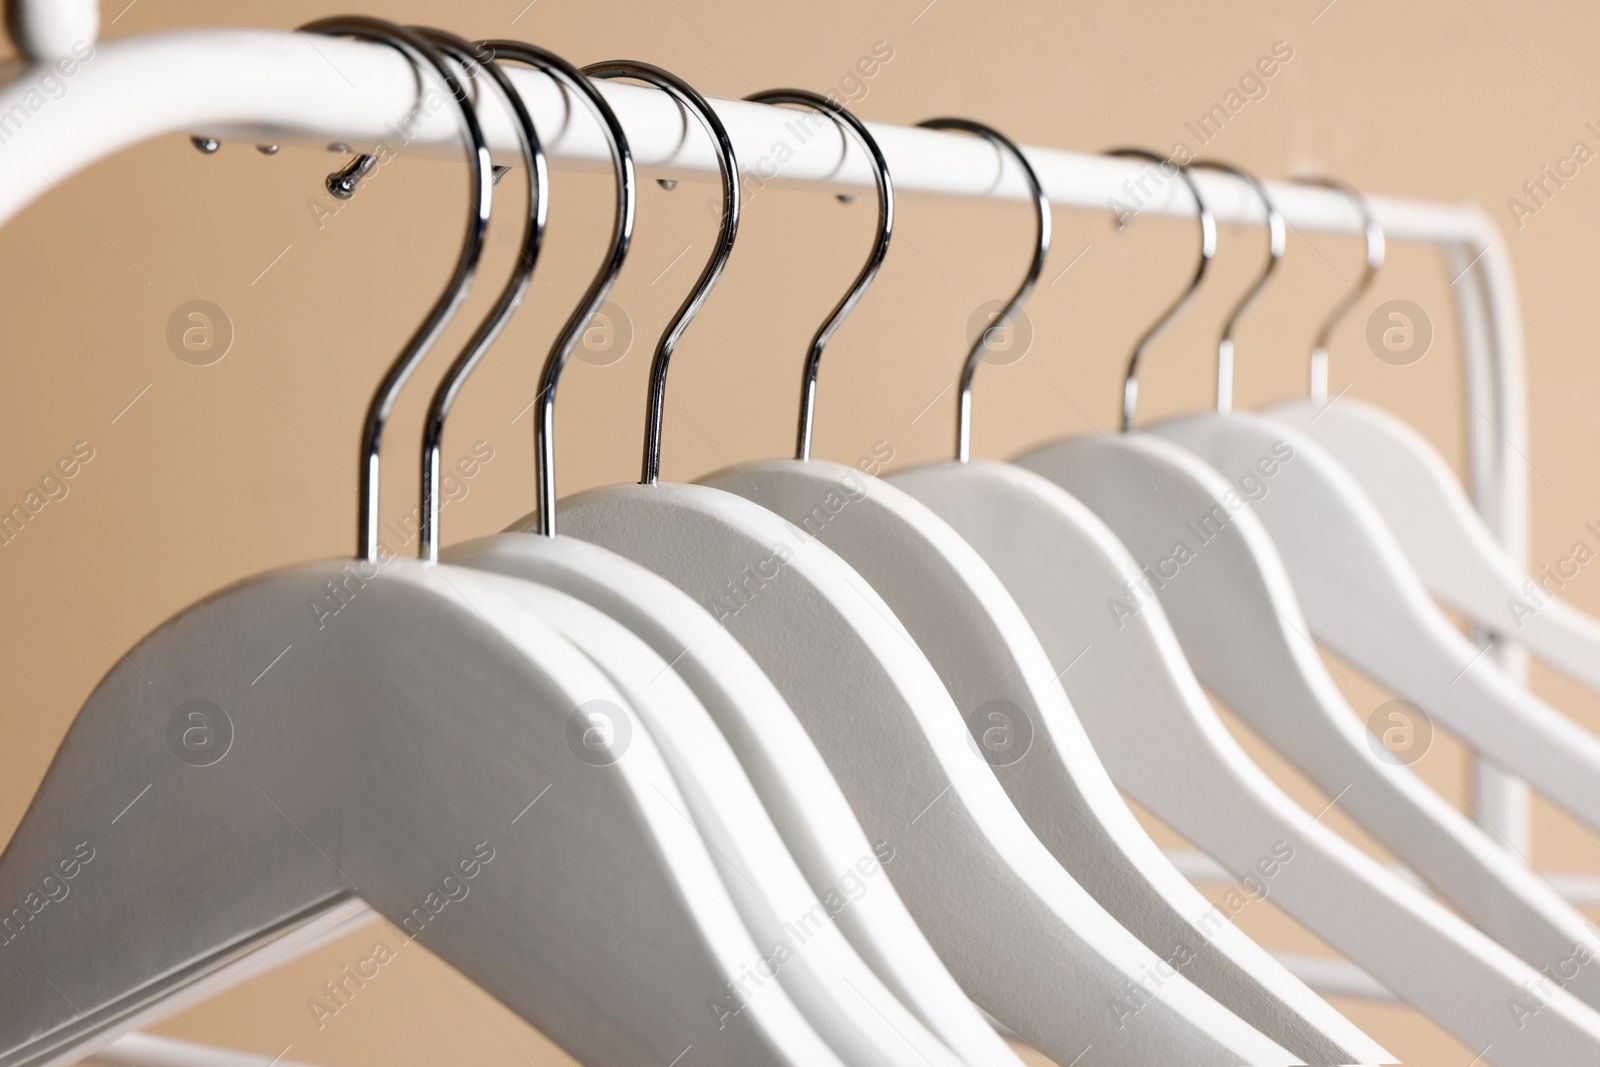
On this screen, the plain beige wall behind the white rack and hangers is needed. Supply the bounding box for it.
[0,0,1600,1067]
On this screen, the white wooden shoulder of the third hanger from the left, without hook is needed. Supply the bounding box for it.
[445,533,1018,1065]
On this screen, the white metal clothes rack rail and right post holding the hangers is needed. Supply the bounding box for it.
[0,22,1528,1011]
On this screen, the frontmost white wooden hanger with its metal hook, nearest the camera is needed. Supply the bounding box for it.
[0,18,838,1067]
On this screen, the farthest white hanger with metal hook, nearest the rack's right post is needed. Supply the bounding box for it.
[1264,179,1600,689]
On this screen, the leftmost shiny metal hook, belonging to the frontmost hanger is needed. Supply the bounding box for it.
[301,16,493,561]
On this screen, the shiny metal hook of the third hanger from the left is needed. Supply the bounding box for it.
[478,40,637,537]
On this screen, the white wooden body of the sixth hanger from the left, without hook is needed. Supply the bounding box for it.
[915,152,1600,1064]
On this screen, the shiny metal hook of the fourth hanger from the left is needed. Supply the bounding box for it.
[584,59,739,485]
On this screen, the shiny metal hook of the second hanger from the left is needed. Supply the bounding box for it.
[414,26,550,563]
